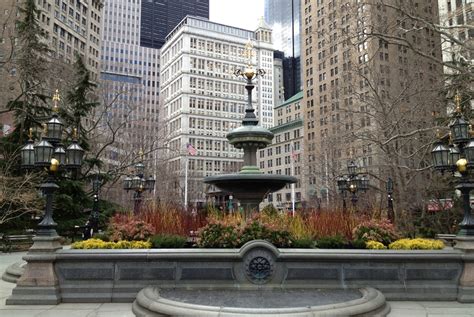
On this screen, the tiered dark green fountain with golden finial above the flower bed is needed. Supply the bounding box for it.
[204,42,297,211]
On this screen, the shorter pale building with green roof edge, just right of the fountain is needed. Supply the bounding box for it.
[257,91,309,210]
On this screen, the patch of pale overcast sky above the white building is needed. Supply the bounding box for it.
[209,0,264,30]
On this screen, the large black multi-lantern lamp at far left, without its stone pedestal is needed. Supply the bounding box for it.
[20,90,84,237]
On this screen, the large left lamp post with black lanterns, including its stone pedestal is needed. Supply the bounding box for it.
[6,90,84,305]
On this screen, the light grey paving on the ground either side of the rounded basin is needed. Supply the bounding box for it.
[0,252,474,317]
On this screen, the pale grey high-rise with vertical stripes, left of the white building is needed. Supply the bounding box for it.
[99,0,160,204]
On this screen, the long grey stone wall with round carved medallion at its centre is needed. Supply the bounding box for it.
[54,241,463,302]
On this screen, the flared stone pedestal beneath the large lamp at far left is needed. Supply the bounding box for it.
[6,234,62,305]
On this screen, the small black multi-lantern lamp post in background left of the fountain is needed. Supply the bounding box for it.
[123,154,156,214]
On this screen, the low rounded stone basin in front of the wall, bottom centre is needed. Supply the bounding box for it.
[132,286,390,316]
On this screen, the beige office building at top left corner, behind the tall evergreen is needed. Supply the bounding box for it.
[0,0,103,131]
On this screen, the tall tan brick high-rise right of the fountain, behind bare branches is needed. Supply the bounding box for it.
[301,0,442,209]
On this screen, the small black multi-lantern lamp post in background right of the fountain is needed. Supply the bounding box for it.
[337,160,369,213]
